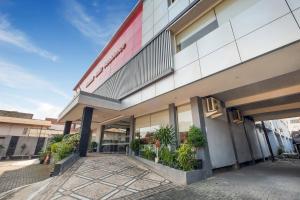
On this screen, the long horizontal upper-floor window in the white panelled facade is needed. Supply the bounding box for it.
[175,11,219,52]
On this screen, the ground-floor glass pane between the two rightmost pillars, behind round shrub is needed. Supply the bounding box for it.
[177,104,193,143]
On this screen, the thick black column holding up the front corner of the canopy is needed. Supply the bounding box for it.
[79,107,94,157]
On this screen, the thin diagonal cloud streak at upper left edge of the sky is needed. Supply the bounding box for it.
[0,14,58,62]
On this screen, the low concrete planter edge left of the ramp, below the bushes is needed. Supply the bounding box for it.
[51,153,80,176]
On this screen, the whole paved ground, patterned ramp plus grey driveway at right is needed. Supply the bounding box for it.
[31,155,300,200]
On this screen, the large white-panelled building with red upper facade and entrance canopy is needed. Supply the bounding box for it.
[59,0,300,177]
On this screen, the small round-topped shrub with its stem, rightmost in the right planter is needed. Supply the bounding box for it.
[187,126,206,169]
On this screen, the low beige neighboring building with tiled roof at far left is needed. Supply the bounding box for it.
[0,110,64,159]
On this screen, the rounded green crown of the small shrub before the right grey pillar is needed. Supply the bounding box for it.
[187,126,206,148]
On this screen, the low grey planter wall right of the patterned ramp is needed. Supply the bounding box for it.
[134,156,209,185]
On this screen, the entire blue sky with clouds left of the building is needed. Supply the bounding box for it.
[0,0,137,119]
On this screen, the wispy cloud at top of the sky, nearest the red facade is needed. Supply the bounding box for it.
[65,0,113,44]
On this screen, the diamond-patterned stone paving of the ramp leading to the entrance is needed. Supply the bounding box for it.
[39,155,174,200]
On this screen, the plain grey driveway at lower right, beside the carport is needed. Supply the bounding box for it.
[145,160,300,200]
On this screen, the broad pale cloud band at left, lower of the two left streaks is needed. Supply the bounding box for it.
[0,60,69,99]
